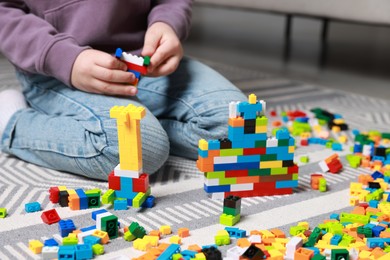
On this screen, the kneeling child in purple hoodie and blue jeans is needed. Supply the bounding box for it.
[0,0,246,180]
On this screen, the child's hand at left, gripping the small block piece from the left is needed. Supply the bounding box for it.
[71,49,137,96]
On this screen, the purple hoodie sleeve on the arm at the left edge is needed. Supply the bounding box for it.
[0,0,88,86]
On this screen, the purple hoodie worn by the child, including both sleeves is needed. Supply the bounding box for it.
[0,0,192,86]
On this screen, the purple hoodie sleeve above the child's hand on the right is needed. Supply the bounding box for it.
[148,0,193,40]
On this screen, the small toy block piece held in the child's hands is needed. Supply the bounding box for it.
[115,48,150,86]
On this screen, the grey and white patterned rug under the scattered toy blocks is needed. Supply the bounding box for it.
[0,56,390,259]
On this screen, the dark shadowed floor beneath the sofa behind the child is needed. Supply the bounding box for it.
[184,6,390,100]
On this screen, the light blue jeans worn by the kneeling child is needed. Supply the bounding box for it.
[1,58,246,180]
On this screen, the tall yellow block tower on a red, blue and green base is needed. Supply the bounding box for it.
[109,104,150,208]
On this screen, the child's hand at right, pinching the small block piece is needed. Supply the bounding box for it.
[142,22,183,77]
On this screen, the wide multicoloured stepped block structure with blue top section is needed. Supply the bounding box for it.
[197,94,298,199]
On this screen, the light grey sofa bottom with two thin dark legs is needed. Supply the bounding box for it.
[195,0,390,66]
